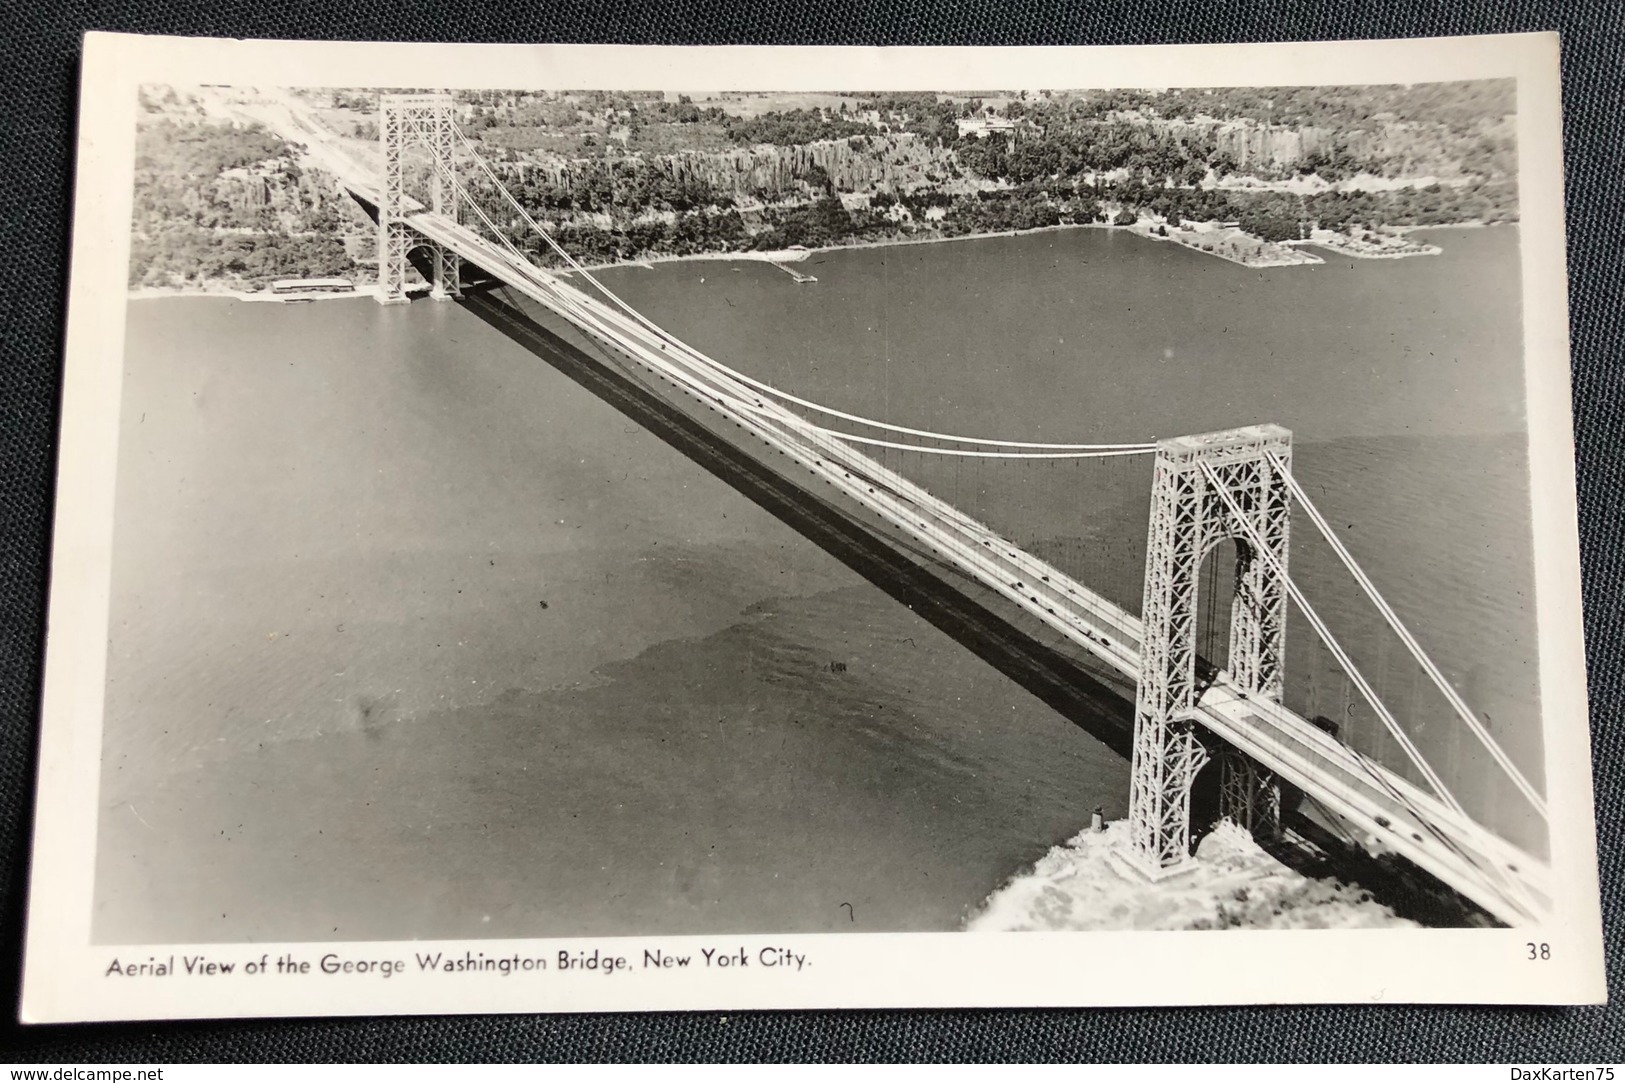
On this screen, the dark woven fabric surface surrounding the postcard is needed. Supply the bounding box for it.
[0,0,1625,1063]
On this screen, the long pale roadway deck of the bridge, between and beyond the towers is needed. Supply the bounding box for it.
[237,90,1549,924]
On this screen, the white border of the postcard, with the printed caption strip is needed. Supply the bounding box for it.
[23,34,1606,1021]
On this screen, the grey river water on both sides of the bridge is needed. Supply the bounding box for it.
[96,222,1544,942]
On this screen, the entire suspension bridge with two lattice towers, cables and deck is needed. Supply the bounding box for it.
[237,94,1552,925]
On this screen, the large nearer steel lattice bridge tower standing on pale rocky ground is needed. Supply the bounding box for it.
[1126,424,1292,878]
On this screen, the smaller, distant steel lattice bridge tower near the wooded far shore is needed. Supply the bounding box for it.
[379,94,462,304]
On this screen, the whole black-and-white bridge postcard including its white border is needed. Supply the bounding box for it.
[28,31,1601,1018]
